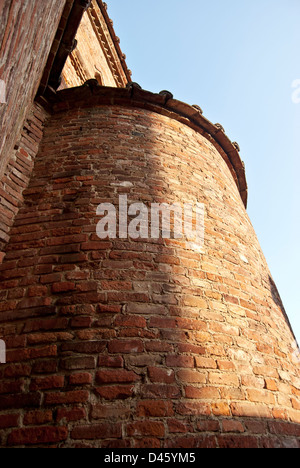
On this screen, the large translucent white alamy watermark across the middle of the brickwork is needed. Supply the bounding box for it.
[97,195,205,248]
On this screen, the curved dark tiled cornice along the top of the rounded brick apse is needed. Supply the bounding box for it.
[40,80,248,207]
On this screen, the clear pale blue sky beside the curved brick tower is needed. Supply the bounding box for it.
[107,0,300,342]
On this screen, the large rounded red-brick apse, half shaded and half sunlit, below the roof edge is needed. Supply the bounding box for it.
[0,86,300,448]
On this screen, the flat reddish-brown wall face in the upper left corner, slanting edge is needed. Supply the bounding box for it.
[0,0,65,178]
